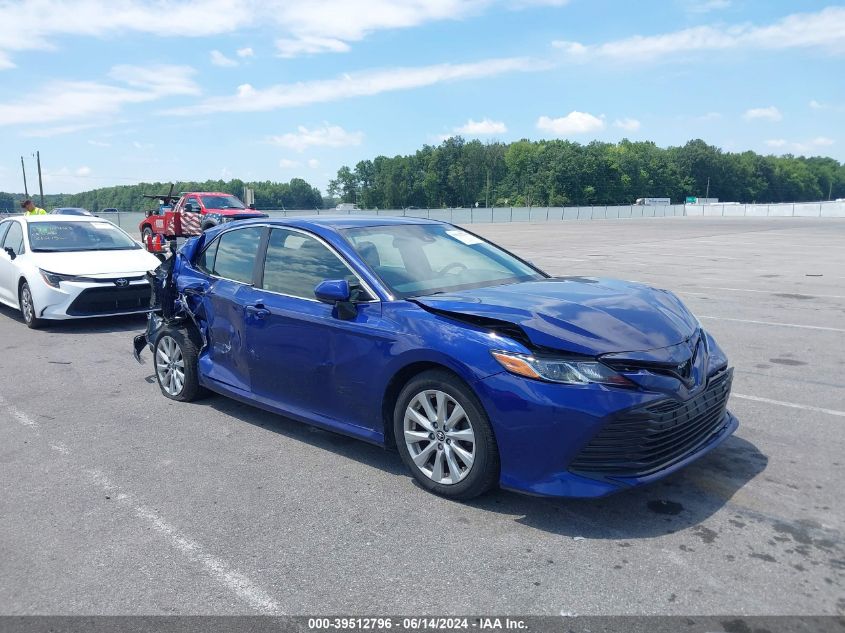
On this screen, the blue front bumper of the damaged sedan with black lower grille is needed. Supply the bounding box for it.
[476,370,738,497]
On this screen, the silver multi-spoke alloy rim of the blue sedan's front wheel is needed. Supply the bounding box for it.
[403,389,475,485]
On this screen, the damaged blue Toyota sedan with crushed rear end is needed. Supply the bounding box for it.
[136,217,737,499]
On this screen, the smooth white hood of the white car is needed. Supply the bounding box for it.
[30,248,161,277]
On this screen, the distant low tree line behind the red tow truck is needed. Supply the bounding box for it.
[0,178,323,213]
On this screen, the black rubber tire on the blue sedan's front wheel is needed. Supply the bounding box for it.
[393,370,499,500]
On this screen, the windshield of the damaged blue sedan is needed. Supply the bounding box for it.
[342,224,545,298]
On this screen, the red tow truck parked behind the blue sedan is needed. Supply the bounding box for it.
[138,191,267,239]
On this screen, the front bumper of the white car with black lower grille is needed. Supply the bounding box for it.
[30,273,150,320]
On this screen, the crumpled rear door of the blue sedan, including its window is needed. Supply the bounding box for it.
[195,226,264,392]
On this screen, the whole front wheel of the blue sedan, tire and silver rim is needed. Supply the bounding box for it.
[393,370,499,499]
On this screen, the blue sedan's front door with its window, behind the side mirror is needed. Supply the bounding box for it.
[247,227,391,433]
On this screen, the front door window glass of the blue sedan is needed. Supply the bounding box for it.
[262,229,358,299]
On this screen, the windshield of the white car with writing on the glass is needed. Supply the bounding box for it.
[28,222,141,253]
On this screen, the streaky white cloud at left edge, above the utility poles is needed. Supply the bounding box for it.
[0,65,199,128]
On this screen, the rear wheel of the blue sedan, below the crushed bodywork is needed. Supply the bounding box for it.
[153,328,206,402]
